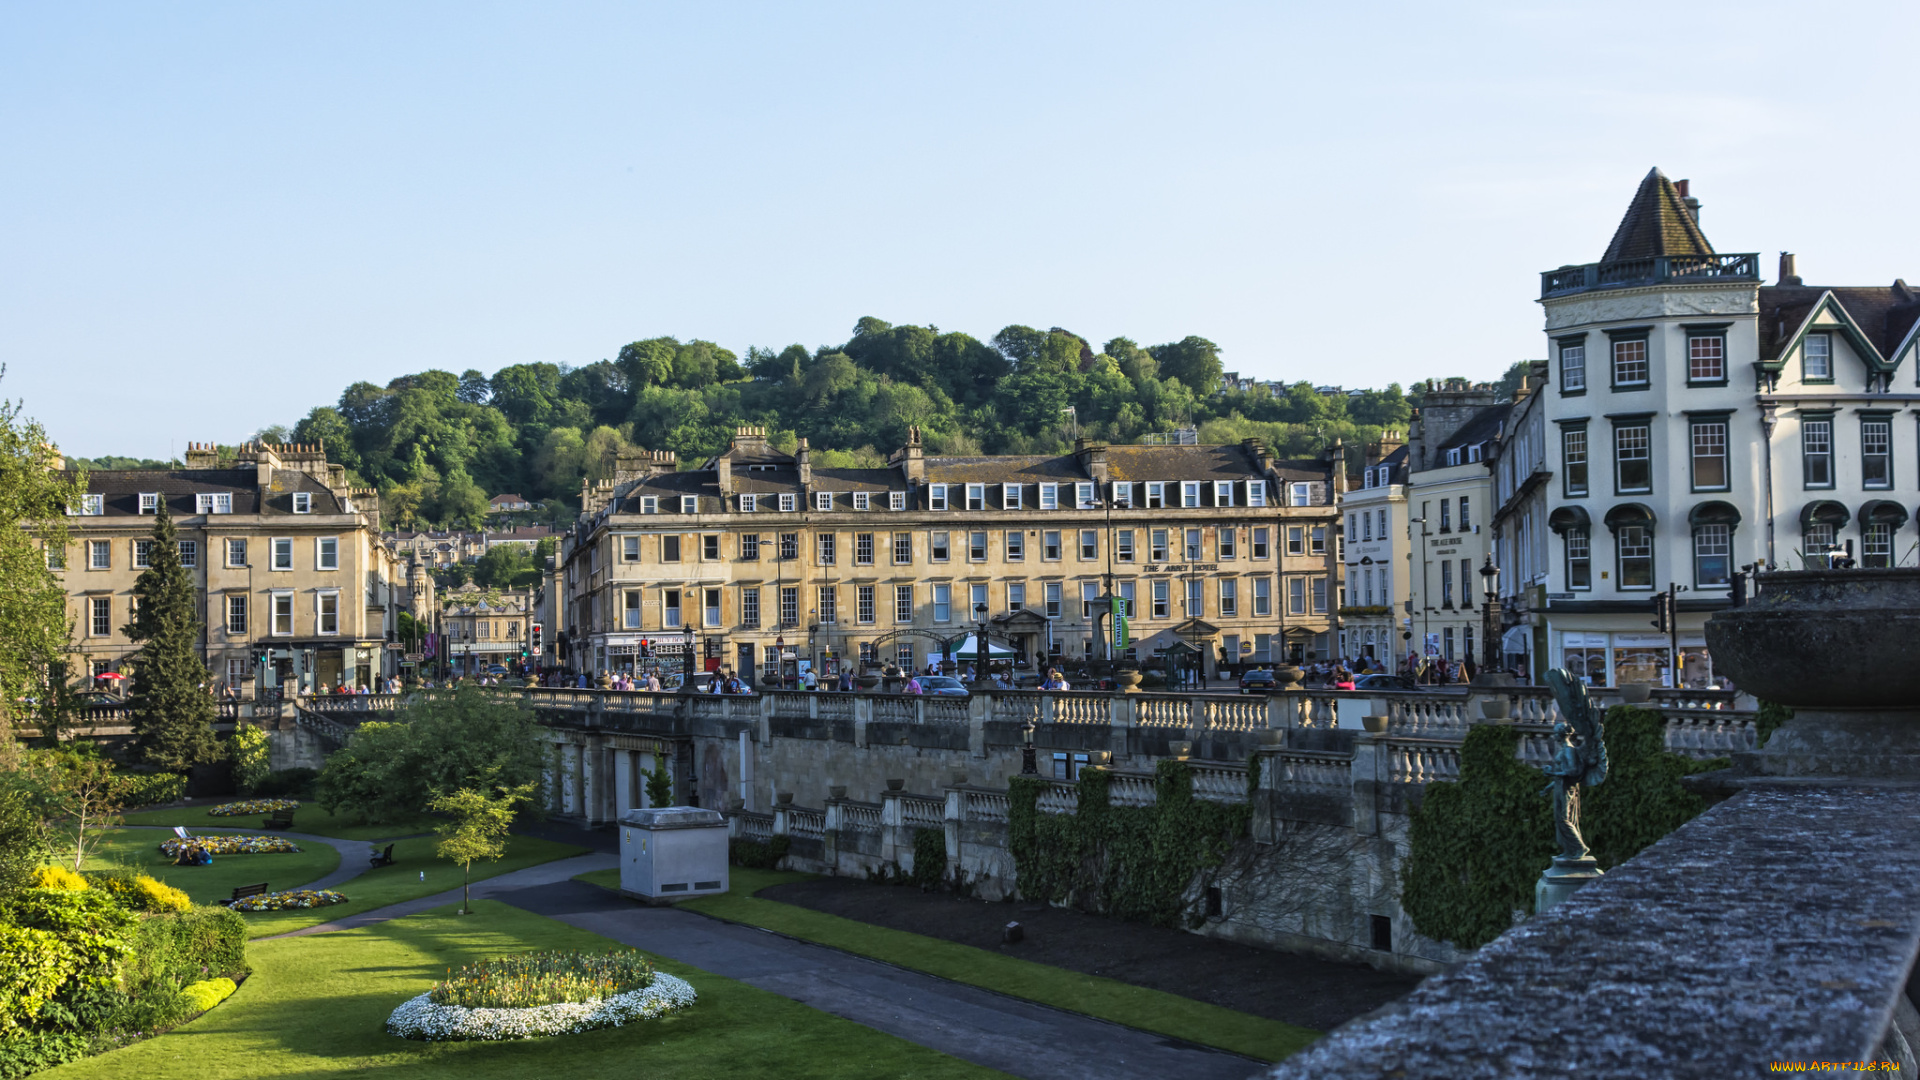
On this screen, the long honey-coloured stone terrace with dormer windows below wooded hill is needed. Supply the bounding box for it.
[559,429,1344,675]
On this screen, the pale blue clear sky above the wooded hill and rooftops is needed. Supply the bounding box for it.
[0,0,1920,457]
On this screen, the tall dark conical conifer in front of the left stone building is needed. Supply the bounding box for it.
[121,500,219,773]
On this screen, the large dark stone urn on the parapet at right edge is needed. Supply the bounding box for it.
[1707,569,1920,780]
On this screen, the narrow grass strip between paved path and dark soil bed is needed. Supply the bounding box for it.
[578,867,1319,1061]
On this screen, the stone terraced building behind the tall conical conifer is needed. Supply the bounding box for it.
[61,444,399,690]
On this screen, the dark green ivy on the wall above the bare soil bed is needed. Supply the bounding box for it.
[1006,759,1252,926]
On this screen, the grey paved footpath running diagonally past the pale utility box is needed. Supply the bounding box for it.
[257,851,1261,1080]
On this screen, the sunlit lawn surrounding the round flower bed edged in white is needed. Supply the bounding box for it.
[42,901,1002,1080]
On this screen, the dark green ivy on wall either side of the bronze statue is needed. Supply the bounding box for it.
[1400,705,1726,949]
